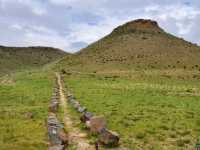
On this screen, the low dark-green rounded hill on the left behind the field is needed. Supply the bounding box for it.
[0,46,66,74]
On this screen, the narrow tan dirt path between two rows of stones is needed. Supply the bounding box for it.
[56,73,95,150]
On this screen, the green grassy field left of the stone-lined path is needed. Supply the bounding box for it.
[0,71,53,150]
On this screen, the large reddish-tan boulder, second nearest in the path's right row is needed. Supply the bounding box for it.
[90,116,106,133]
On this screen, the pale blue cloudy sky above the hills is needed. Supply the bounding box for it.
[0,0,200,52]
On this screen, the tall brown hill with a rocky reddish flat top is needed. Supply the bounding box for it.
[60,19,200,71]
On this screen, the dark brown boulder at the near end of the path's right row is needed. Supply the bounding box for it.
[99,128,119,147]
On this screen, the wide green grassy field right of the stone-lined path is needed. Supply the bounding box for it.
[65,70,200,150]
